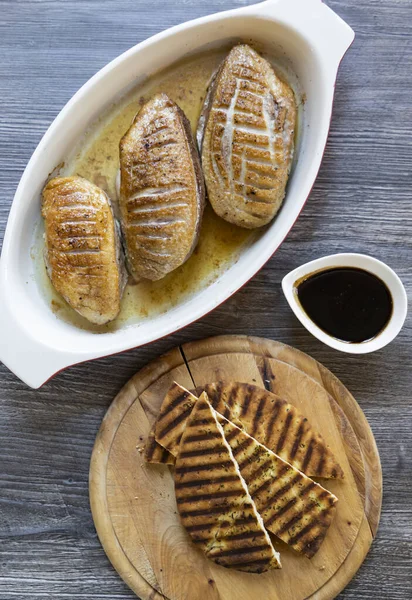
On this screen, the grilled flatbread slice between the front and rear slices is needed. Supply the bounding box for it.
[217,414,338,558]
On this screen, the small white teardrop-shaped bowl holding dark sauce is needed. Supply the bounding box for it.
[282,254,408,354]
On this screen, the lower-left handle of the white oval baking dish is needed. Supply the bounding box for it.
[0,296,72,389]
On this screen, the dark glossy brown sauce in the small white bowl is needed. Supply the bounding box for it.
[296,267,393,343]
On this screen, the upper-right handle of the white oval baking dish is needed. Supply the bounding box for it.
[253,0,355,67]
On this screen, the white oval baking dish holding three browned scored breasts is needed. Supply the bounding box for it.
[0,0,354,388]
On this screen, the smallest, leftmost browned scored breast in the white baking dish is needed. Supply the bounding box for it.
[42,176,127,325]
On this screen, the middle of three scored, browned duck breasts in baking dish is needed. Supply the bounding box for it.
[119,94,205,280]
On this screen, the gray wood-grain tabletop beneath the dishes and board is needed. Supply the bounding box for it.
[0,0,412,600]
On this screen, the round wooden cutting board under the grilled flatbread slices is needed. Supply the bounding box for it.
[90,336,382,600]
